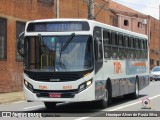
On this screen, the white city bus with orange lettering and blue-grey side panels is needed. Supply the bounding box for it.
[18,19,150,109]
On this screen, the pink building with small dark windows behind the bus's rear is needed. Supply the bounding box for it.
[109,0,160,69]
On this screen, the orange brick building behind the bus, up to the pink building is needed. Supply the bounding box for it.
[0,0,116,93]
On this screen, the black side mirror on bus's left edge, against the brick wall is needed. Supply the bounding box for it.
[17,32,24,57]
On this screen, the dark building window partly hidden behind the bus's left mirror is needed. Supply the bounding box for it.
[16,22,26,61]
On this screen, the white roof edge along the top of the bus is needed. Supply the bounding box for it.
[27,18,148,39]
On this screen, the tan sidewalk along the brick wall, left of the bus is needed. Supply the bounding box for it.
[0,91,24,104]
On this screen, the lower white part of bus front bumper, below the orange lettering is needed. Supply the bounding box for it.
[23,84,95,102]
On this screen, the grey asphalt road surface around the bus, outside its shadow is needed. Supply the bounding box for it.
[0,81,160,120]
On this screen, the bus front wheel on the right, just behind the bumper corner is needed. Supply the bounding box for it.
[97,89,108,108]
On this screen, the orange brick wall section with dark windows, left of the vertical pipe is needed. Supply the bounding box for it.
[0,0,54,93]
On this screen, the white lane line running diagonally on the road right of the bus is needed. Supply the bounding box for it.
[75,94,160,120]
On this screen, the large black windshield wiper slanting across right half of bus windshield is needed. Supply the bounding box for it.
[59,33,75,61]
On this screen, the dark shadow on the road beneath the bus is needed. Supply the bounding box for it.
[27,95,147,113]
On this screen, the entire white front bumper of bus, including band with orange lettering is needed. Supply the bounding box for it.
[23,73,95,102]
